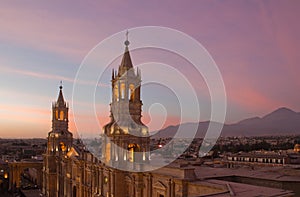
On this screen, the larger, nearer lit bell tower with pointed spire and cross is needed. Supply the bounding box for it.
[102,32,150,169]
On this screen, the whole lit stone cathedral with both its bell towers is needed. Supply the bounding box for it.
[42,36,290,197]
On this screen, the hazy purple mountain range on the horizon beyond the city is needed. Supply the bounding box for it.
[153,107,300,138]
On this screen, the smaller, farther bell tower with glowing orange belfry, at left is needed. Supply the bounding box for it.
[43,84,73,197]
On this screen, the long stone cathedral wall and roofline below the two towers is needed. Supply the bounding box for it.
[46,147,228,197]
